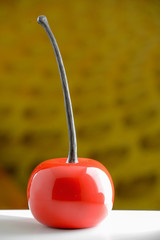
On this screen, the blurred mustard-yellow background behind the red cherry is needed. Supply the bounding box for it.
[0,0,160,209]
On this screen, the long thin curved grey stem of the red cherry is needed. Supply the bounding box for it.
[37,15,78,163]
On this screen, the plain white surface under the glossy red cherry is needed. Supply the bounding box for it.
[0,210,160,240]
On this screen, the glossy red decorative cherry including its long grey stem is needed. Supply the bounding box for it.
[27,16,114,228]
